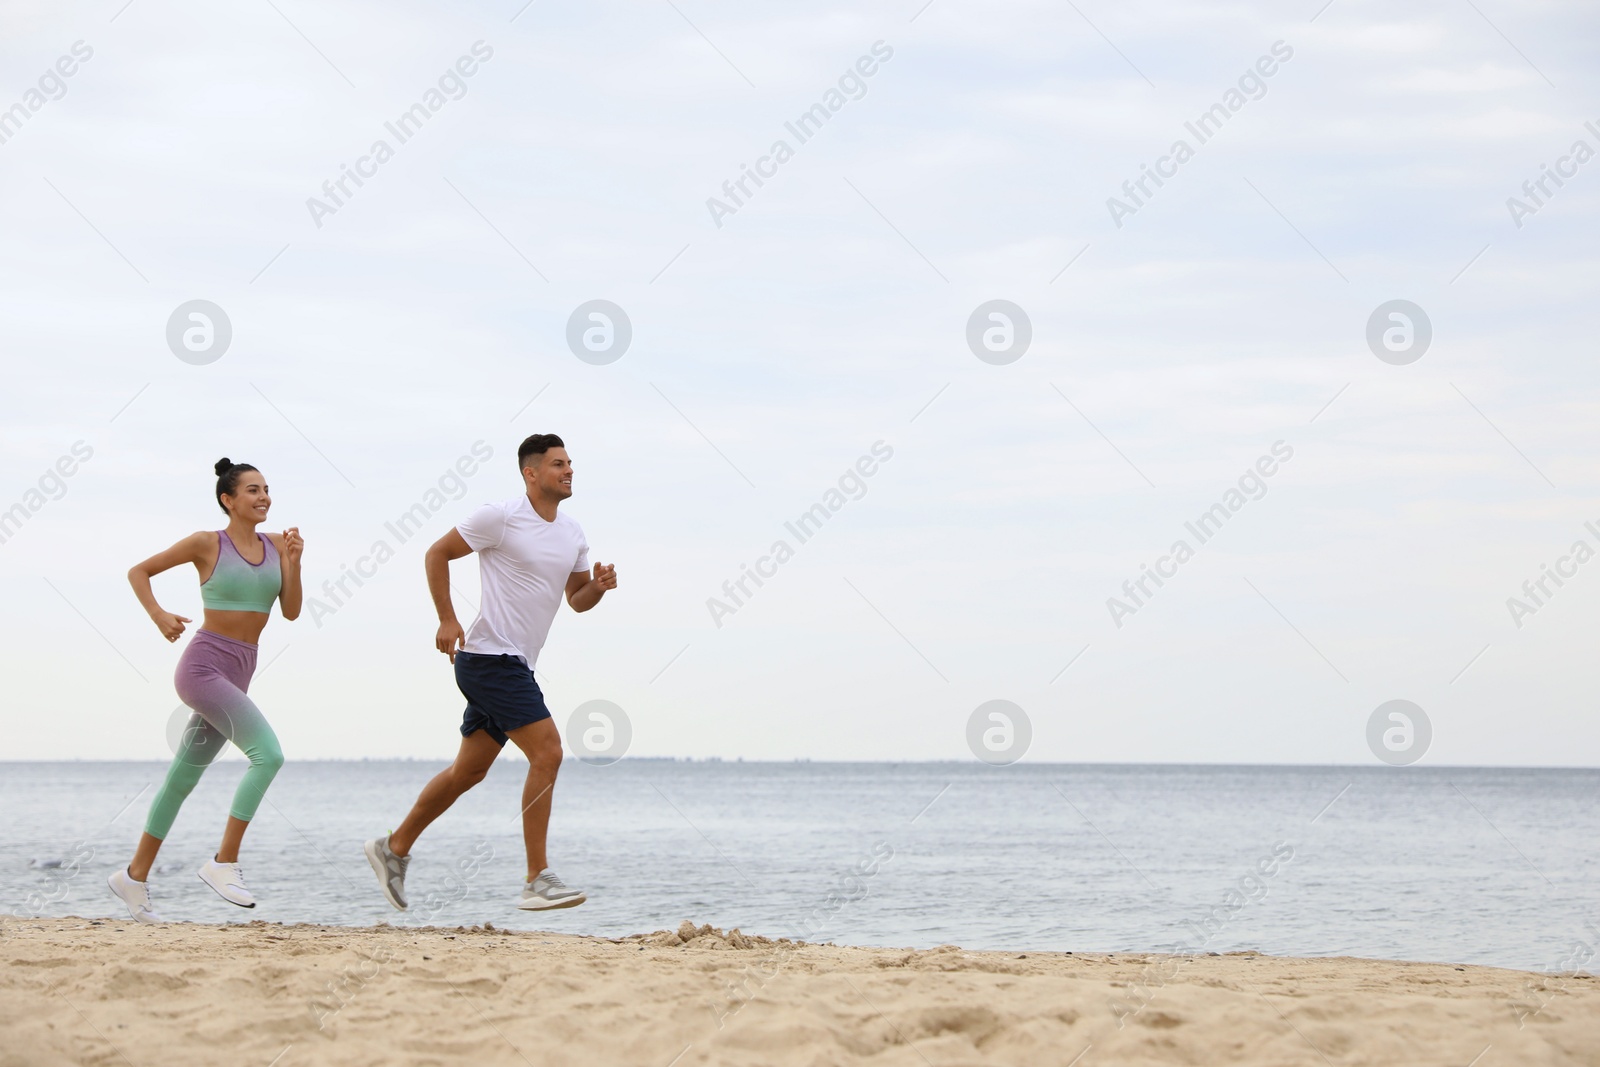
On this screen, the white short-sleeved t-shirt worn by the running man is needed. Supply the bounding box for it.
[456,494,589,669]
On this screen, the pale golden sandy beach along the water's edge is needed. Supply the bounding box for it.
[0,918,1600,1067]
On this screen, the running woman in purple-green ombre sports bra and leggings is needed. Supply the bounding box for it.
[107,459,304,923]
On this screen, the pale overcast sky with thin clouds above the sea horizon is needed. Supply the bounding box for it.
[0,0,1600,766]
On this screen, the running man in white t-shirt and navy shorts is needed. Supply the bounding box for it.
[366,434,616,910]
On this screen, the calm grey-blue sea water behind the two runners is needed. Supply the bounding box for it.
[0,760,1600,971]
